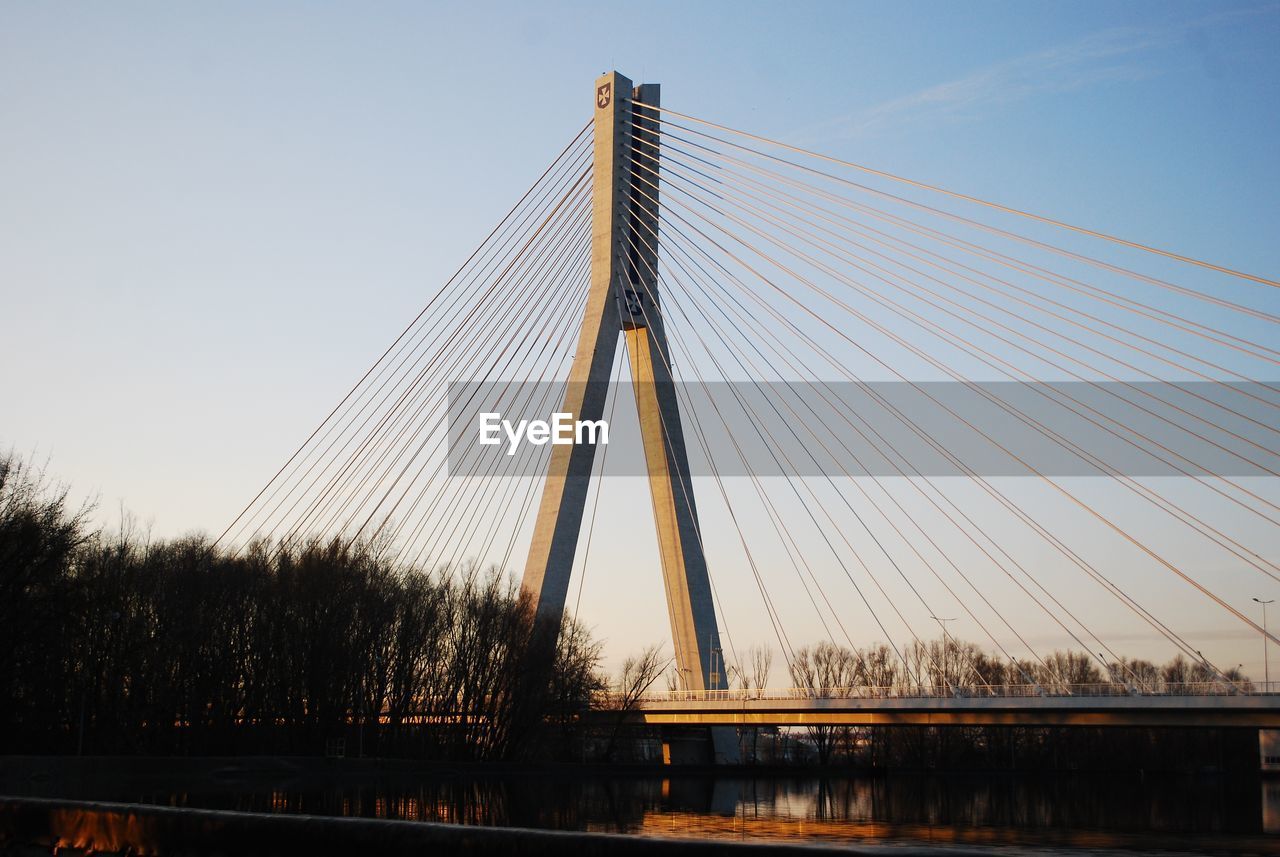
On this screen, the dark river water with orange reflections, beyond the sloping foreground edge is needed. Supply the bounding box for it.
[7,771,1280,852]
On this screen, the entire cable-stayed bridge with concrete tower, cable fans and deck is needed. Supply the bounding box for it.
[219,73,1280,746]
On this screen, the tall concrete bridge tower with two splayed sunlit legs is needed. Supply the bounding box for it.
[522,72,739,761]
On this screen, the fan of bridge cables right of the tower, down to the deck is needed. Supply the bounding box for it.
[616,102,1280,684]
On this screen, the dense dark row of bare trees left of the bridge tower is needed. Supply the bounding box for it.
[0,457,602,759]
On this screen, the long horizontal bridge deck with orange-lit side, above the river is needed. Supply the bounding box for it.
[631,683,1280,727]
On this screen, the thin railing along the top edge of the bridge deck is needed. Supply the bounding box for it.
[622,682,1280,705]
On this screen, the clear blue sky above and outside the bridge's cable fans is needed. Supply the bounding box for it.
[0,1,1280,673]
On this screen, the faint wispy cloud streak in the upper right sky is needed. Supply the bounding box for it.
[792,6,1275,143]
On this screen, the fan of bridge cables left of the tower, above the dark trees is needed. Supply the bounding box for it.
[218,123,593,568]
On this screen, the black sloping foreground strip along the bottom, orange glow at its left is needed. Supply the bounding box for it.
[0,797,992,857]
